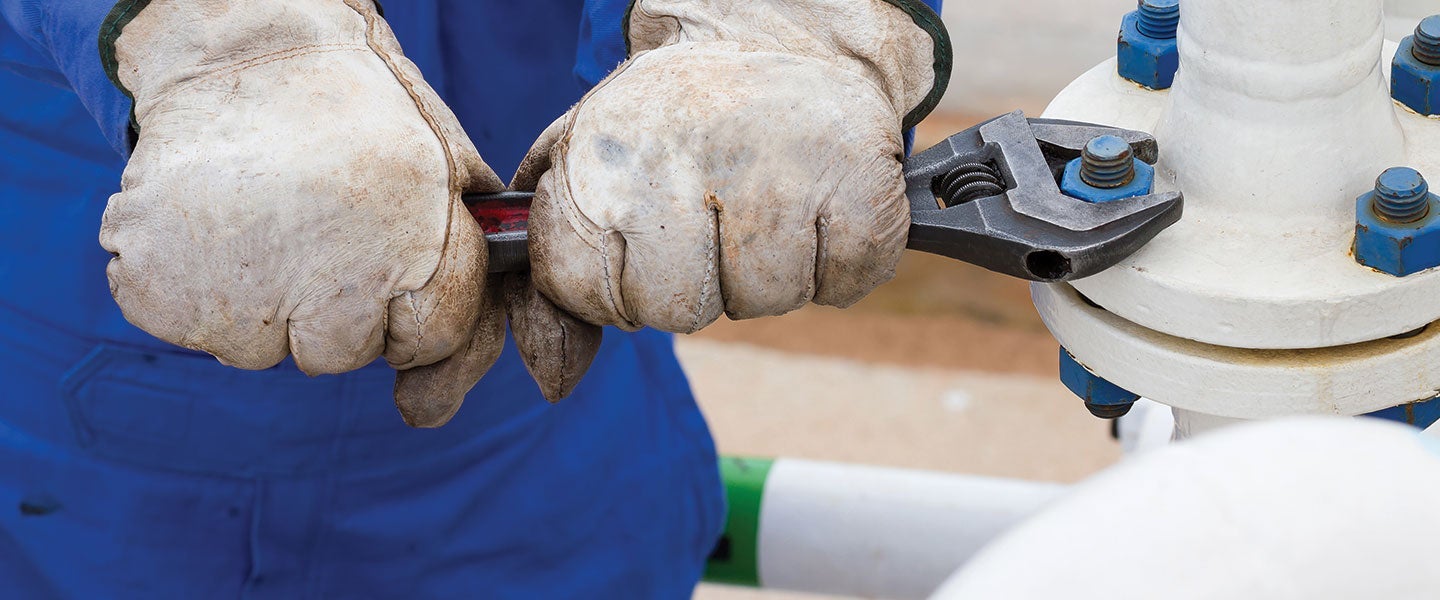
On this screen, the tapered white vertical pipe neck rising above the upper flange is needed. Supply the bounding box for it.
[1155,0,1405,227]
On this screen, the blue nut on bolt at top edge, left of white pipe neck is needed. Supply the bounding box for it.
[1116,0,1179,89]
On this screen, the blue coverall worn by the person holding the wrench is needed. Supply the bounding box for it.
[0,0,723,599]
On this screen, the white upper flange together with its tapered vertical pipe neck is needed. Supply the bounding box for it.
[1045,5,1440,348]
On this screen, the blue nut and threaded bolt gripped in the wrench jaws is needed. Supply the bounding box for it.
[1060,135,1155,203]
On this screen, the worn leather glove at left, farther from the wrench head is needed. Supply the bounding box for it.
[99,0,599,426]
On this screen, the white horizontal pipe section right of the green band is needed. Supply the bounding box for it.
[757,459,1066,599]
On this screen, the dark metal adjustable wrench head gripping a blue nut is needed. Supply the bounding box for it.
[906,111,1184,282]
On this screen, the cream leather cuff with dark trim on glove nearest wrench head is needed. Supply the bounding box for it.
[624,0,953,128]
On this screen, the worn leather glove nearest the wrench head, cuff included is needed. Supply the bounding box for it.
[530,0,950,332]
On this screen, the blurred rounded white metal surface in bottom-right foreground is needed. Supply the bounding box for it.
[935,417,1440,600]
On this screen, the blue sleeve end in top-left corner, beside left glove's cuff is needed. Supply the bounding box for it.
[0,0,131,155]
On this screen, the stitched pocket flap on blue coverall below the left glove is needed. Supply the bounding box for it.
[60,345,347,478]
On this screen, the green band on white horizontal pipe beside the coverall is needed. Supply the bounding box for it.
[704,456,775,587]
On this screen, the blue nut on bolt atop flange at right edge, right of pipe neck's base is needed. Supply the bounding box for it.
[1355,167,1440,276]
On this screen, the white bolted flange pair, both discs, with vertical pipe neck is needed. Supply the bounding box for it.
[1034,0,1440,429]
